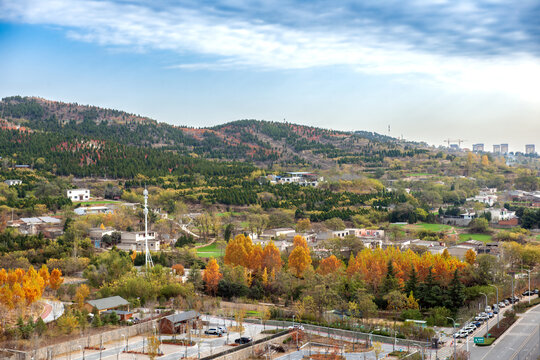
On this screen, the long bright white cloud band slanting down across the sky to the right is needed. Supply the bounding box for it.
[0,0,540,103]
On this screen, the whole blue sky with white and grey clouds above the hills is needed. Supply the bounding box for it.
[0,0,540,151]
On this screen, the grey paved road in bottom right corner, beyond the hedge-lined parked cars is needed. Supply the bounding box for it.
[470,305,540,360]
